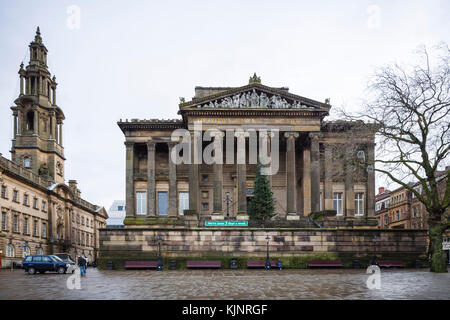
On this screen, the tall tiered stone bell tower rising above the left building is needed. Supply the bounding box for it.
[11,27,65,183]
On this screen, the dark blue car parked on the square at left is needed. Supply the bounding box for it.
[22,255,71,274]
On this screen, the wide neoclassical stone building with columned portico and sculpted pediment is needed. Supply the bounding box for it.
[118,75,375,227]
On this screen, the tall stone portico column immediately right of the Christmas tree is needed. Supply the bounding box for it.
[284,132,299,215]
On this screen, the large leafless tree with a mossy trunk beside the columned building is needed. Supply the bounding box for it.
[346,43,450,272]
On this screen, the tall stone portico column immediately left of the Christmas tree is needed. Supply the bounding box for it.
[235,131,248,214]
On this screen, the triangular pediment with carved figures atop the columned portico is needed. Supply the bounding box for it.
[180,83,330,111]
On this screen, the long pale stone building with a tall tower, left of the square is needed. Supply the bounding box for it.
[0,28,107,266]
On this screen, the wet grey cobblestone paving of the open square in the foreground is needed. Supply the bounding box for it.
[0,268,450,300]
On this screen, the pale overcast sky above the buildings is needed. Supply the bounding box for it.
[0,0,450,209]
